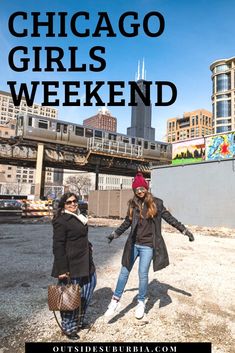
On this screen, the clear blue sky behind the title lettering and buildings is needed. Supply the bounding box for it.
[0,0,235,140]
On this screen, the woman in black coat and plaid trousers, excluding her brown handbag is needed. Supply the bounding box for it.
[52,192,96,340]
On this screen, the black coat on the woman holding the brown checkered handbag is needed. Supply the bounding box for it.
[51,213,95,277]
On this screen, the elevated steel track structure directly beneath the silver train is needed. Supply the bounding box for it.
[0,138,169,176]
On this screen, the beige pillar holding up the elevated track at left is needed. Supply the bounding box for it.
[34,143,45,200]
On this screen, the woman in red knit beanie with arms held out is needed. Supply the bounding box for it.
[105,173,194,319]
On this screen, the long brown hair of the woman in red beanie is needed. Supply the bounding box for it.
[127,191,157,221]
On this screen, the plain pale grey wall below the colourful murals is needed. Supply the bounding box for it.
[151,160,235,228]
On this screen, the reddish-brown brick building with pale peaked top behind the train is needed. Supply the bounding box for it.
[83,107,117,132]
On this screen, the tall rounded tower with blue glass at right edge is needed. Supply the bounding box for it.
[210,57,235,133]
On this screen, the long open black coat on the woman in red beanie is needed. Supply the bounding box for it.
[115,197,186,271]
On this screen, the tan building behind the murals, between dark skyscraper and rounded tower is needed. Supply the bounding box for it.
[167,109,213,143]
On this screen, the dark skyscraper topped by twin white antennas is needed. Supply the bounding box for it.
[127,61,155,141]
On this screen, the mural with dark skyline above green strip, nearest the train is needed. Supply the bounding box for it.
[172,138,205,165]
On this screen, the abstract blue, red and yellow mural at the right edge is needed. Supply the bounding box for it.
[206,131,235,161]
